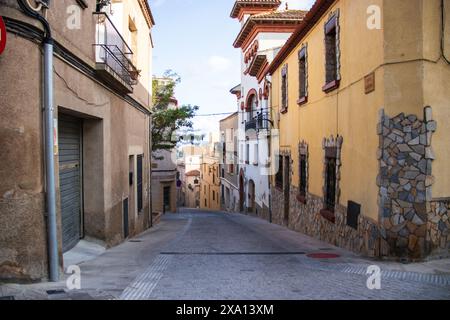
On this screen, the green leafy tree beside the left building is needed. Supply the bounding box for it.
[151,70,199,152]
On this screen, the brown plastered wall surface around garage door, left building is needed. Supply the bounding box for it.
[0,0,151,281]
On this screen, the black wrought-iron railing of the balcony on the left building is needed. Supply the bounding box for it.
[94,12,138,86]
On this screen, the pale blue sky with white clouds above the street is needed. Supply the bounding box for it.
[149,0,314,136]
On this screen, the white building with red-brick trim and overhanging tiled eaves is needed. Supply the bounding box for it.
[231,0,305,219]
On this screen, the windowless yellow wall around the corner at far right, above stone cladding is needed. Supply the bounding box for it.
[384,0,450,198]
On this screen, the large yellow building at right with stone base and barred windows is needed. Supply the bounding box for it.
[259,0,450,259]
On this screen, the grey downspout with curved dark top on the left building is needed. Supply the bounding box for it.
[18,0,59,282]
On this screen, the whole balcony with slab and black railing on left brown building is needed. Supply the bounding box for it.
[94,12,139,94]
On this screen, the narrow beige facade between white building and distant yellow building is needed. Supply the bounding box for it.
[220,112,240,212]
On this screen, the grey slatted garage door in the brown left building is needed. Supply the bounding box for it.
[58,114,82,252]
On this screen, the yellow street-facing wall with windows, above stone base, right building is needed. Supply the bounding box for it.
[272,0,384,219]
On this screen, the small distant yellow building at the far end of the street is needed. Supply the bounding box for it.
[200,156,220,211]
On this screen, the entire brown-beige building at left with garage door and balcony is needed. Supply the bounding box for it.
[0,0,154,281]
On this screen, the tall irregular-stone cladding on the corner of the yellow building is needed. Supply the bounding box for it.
[377,108,436,260]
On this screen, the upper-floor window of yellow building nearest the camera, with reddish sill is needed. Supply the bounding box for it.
[322,12,340,93]
